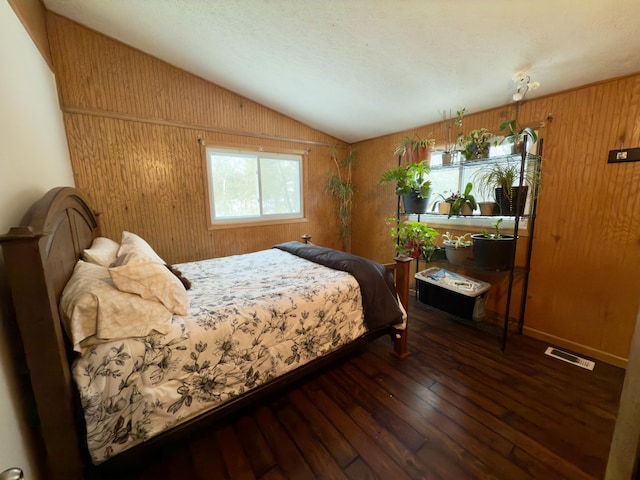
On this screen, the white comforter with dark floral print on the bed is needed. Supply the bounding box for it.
[73,249,366,464]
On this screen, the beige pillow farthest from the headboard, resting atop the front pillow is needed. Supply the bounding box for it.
[109,256,189,315]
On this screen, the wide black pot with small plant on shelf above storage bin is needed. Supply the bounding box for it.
[471,218,516,271]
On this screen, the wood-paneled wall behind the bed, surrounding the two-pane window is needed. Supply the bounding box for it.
[48,12,342,263]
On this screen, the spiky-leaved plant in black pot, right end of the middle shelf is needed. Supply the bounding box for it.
[473,161,531,215]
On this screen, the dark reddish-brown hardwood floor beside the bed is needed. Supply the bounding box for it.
[105,299,624,480]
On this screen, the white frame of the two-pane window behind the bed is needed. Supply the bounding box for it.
[205,145,306,229]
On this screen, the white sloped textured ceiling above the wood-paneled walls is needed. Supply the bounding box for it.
[43,0,640,143]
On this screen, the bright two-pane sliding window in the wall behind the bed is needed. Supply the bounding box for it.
[206,147,304,225]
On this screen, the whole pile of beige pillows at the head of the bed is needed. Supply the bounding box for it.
[60,232,189,352]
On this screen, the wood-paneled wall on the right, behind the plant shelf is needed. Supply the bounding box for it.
[352,72,640,366]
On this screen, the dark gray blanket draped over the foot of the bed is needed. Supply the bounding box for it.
[273,242,402,330]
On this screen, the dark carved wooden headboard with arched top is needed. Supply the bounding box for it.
[0,187,100,478]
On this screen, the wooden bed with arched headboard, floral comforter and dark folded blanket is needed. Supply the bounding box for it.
[0,187,409,479]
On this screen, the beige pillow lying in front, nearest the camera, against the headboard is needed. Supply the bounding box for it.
[60,260,173,352]
